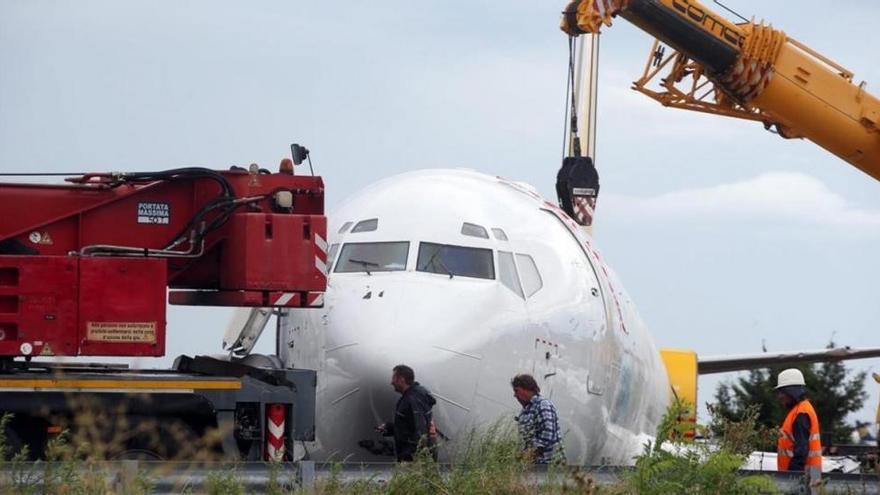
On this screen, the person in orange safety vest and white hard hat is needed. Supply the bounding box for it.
[776,368,822,484]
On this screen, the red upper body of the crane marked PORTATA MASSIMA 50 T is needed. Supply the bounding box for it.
[0,164,327,358]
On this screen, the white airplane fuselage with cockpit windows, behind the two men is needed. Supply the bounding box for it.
[279,170,669,464]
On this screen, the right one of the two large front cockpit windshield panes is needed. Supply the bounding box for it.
[416,242,495,280]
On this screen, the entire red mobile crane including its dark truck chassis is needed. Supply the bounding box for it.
[0,158,327,461]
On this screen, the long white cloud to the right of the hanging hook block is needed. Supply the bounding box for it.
[599,172,880,235]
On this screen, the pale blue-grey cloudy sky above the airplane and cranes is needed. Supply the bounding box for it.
[0,0,880,426]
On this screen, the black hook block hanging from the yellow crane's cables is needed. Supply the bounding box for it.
[556,156,599,227]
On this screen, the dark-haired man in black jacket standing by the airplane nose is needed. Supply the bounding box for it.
[376,364,437,462]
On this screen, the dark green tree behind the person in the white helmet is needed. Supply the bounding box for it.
[712,341,868,451]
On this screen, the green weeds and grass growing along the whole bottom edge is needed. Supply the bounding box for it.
[0,403,777,495]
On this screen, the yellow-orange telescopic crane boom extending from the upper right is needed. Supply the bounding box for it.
[561,0,880,180]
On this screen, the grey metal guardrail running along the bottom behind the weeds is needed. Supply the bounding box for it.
[0,461,880,495]
